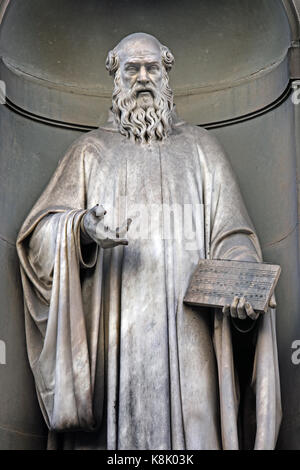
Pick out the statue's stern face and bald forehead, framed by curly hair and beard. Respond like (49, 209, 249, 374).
(119, 40, 163, 109)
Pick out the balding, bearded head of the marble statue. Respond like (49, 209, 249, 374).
(106, 33, 174, 143)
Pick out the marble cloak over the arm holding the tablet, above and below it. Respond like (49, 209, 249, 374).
(198, 133, 282, 449)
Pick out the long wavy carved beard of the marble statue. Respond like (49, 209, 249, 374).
(112, 70, 173, 143)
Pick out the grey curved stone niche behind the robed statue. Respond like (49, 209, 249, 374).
(0, 0, 300, 449)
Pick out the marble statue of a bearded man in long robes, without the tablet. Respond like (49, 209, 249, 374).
(17, 33, 281, 450)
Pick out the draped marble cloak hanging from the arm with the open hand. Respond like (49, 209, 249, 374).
(17, 135, 101, 431)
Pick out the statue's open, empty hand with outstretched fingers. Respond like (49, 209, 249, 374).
(83, 204, 131, 248)
